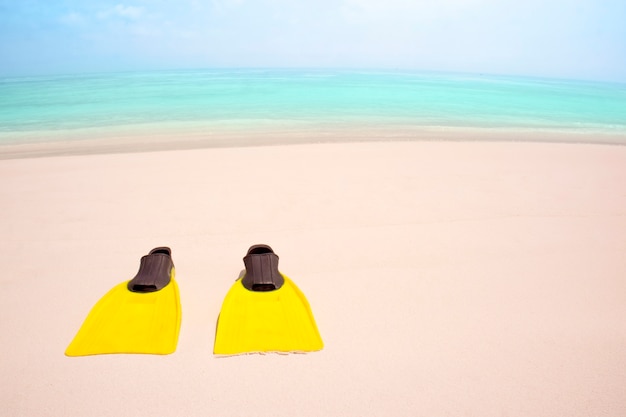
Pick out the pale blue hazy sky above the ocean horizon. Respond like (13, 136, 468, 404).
(0, 0, 626, 82)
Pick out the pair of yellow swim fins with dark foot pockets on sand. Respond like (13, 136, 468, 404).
(65, 245, 324, 356)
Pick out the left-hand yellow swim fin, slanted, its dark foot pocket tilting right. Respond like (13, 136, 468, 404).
(65, 247, 181, 356)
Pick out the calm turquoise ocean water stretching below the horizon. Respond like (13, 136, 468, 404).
(0, 69, 626, 144)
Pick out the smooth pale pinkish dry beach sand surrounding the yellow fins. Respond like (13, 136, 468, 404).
(0, 142, 626, 417)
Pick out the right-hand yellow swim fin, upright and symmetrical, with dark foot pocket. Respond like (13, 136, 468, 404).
(213, 245, 324, 355)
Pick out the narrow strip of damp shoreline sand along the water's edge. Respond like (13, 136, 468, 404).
(0, 126, 626, 160)
